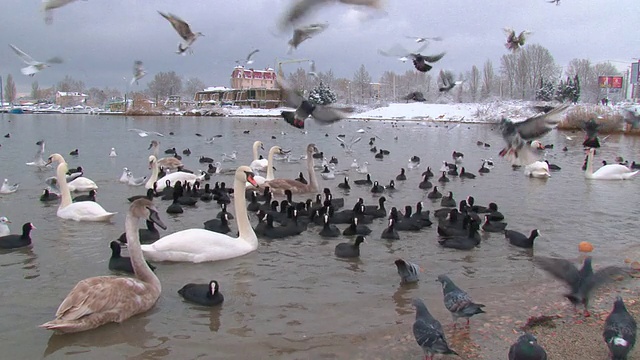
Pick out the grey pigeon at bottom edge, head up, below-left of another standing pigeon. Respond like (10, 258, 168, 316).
(413, 299, 458, 360)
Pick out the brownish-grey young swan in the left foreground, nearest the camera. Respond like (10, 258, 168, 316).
(40, 198, 167, 333)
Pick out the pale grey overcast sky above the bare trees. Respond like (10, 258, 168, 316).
(0, 0, 640, 93)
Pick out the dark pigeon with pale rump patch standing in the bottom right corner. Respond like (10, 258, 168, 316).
(602, 296, 637, 360)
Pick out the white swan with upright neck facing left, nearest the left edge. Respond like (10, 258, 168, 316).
(49, 154, 117, 221)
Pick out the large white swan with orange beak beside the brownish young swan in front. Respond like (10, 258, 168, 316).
(142, 166, 258, 263)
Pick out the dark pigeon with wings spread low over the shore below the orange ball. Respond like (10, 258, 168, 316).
(534, 256, 624, 316)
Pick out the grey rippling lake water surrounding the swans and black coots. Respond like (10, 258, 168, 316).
(0, 114, 640, 359)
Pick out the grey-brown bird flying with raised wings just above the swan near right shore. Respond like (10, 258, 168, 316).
(500, 104, 569, 165)
